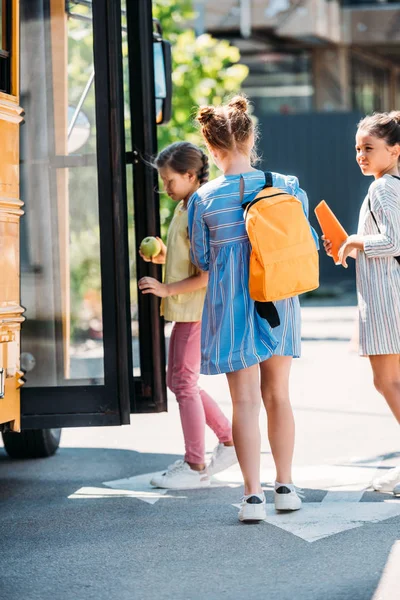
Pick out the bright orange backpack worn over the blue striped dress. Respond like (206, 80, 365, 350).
(240, 172, 319, 322)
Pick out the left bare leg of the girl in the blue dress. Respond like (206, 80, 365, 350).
(226, 365, 262, 495)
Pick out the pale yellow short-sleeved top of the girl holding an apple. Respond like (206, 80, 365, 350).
(160, 200, 207, 323)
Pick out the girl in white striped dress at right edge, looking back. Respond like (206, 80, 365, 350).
(324, 111, 400, 493)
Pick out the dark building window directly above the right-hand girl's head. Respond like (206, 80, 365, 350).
(351, 57, 390, 113)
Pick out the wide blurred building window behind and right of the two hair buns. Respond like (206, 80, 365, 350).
(242, 52, 314, 115)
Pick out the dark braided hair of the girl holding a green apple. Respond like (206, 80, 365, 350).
(154, 142, 209, 185)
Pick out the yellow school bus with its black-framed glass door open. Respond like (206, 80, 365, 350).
(0, 0, 171, 457)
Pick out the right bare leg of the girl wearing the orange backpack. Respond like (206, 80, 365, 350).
(260, 356, 295, 483)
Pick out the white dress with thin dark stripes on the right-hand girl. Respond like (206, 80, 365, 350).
(356, 175, 400, 356)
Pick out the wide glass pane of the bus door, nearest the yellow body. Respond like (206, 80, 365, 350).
(21, 0, 104, 387)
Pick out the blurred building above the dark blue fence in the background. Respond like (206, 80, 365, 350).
(195, 0, 400, 114)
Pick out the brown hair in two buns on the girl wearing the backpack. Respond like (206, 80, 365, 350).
(197, 95, 257, 161)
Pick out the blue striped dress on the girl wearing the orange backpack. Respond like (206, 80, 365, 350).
(188, 170, 318, 375)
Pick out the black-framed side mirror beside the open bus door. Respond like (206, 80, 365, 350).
(153, 38, 172, 125)
